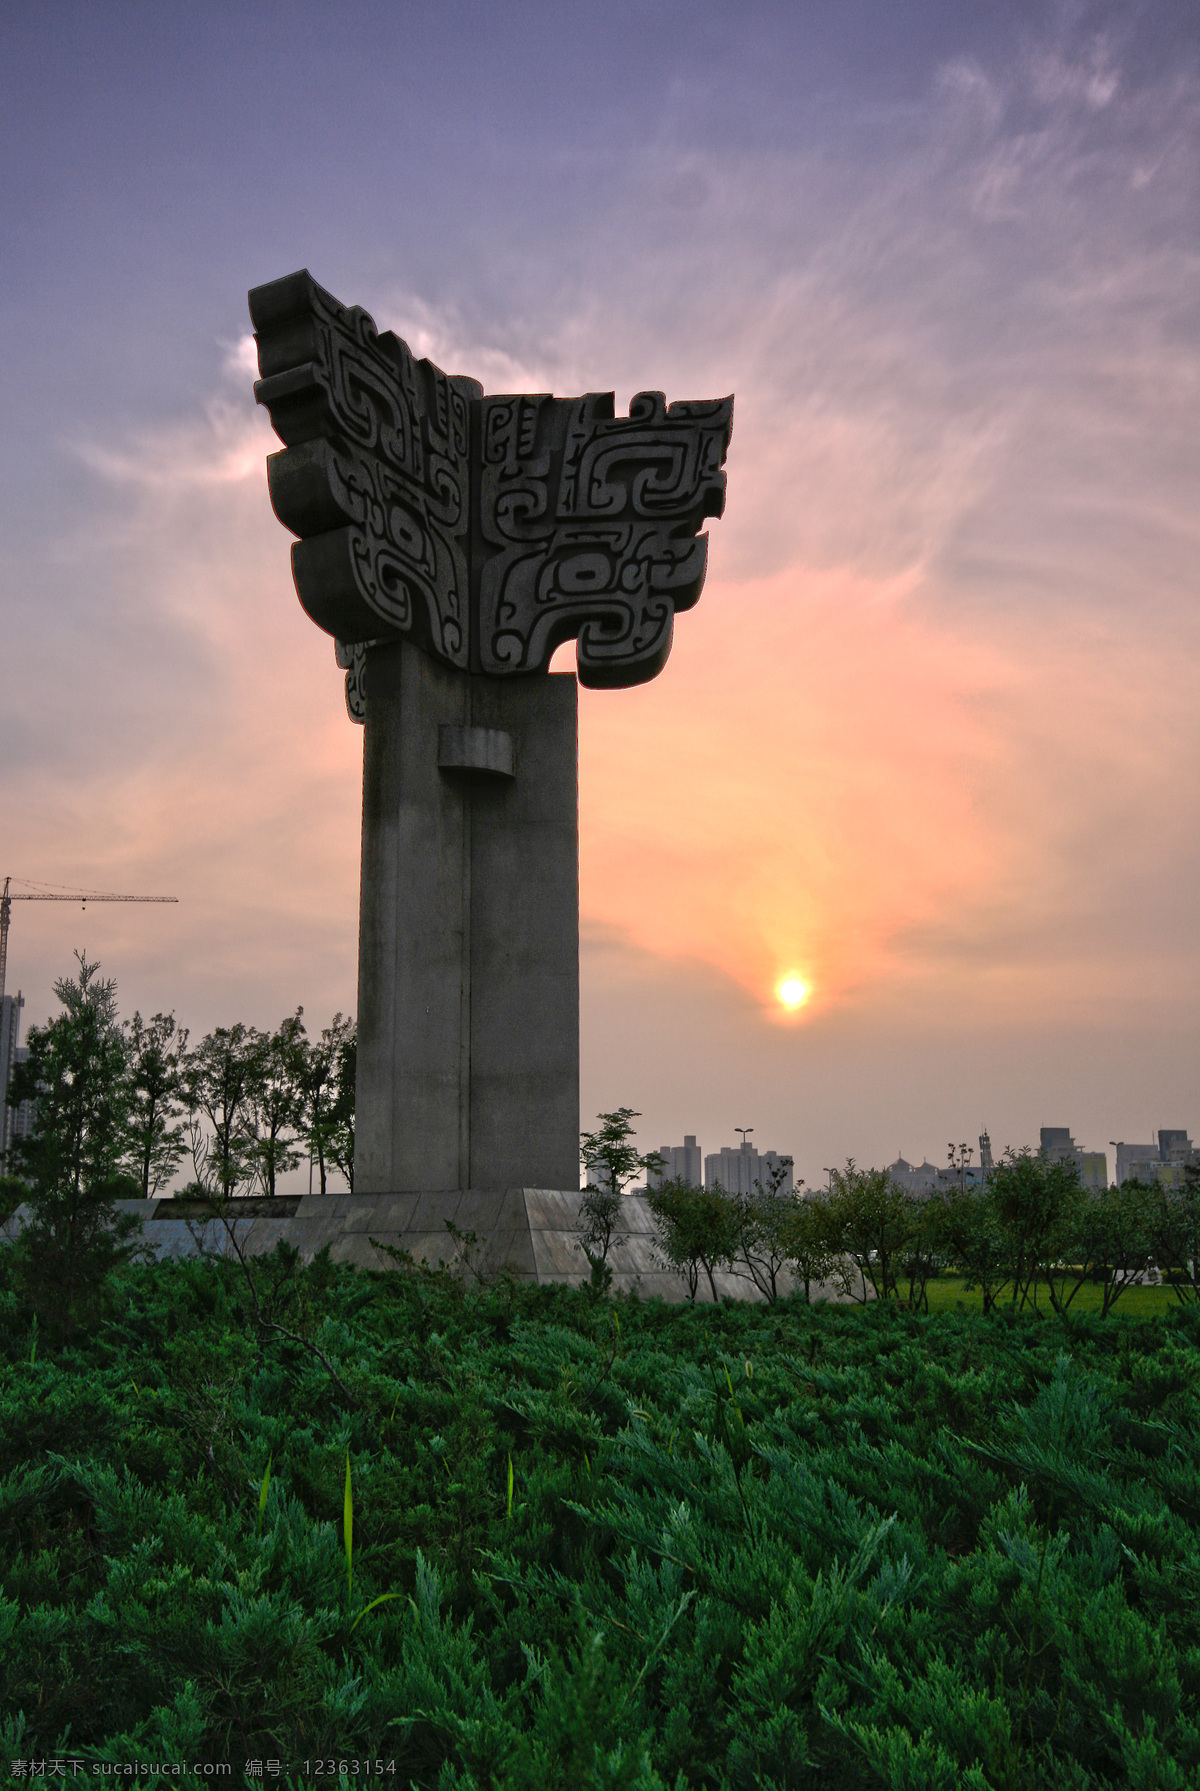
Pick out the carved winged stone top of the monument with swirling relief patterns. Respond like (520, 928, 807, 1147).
(251, 272, 733, 691)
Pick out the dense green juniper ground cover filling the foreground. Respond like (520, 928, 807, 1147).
(0, 1252, 1200, 1791)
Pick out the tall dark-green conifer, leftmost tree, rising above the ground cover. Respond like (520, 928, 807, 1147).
(9, 953, 140, 1343)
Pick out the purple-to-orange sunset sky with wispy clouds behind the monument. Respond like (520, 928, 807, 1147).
(0, 0, 1200, 1186)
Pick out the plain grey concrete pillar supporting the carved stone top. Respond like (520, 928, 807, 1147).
(355, 641, 579, 1193)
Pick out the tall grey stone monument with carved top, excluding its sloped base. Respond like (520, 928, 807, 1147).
(249, 272, 733, 1268)
